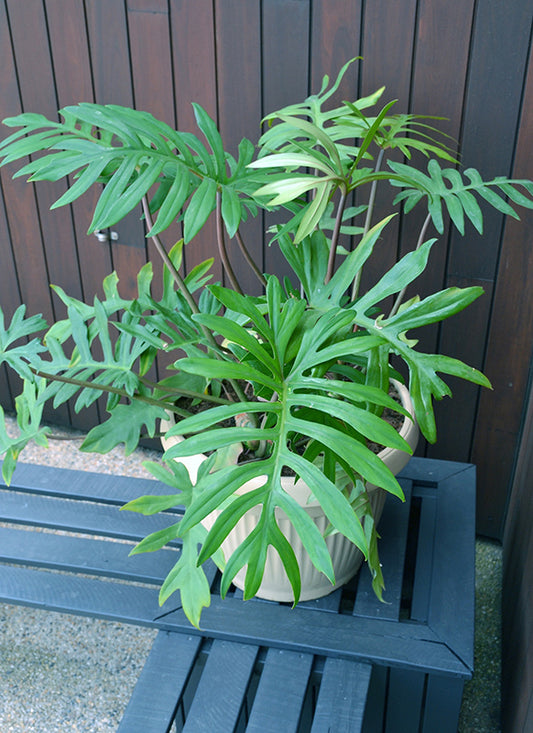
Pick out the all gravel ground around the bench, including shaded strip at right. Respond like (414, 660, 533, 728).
(0, 414, 501, 733)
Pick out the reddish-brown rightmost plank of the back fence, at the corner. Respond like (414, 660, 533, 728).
(472, 35, 533, 537)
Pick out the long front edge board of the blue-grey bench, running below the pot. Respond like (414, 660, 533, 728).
(0, 567, 470, 677)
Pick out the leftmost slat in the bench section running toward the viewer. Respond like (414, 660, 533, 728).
(118, 631, 201, 733)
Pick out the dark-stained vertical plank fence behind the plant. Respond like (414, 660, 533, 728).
(0, 0, 533, 537)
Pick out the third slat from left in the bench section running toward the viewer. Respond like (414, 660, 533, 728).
(246, 649, 313, 733)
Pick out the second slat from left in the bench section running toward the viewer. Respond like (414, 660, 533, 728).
(183, 641, 259, 733)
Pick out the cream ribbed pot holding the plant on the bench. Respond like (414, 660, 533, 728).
(162, 380, 419, 602)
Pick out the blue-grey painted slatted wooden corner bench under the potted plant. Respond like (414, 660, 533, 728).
(0, 458, 475, 733)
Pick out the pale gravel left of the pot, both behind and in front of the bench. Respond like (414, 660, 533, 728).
(0, 419, 159, 733)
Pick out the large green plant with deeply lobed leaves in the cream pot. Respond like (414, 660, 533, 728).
(0, 64, 533, 624)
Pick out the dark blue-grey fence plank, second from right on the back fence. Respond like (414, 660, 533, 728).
(427, 0, 533, 468)
